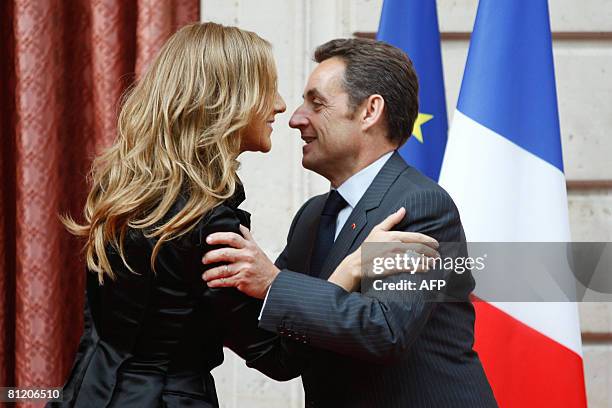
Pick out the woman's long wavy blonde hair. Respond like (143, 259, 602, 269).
(62, 23, 276, 283)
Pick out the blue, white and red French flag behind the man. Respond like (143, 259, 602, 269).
(440, 0, 586, 407)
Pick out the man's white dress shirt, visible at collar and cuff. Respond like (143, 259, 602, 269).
(259, 151, 393, 320)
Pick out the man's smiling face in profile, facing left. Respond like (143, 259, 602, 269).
(289, 57, 361, 181)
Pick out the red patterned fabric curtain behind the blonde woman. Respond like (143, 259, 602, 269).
(0, 0, 199, 396)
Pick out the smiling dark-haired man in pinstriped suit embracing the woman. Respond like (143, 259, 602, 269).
(205, 39, 496, 407)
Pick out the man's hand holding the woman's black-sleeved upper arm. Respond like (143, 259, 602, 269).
(202, 225, 280, 299)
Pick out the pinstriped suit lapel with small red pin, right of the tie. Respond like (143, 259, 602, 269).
(318, 151, 408, 279)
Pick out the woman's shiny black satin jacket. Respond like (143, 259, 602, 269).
(50, 186, 298, 408)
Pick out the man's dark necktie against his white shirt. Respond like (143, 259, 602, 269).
(310, 190, 348, 276)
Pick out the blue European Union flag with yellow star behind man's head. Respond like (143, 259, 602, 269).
(377, 0, 448, 180)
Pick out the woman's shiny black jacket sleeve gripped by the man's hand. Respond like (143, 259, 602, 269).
(198, 207, 300, 381)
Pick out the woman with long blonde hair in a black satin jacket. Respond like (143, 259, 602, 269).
(51, 23, 436, 408)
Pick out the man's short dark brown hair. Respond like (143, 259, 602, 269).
(314, 38, 419, 146)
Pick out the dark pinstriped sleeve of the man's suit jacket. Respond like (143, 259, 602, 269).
(260, 191, 471, 363)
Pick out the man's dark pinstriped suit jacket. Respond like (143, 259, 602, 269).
(260, 152, 496, 407)
